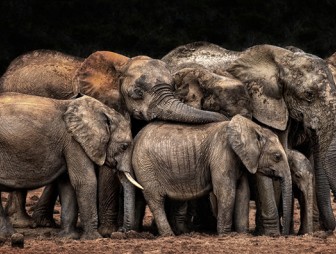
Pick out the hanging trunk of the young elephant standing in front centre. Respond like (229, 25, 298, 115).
(280, 174, 293, 235)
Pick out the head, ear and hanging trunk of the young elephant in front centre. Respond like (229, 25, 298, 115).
(228, 115, 292, 235)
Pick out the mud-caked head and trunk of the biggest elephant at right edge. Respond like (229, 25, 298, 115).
(226, 45, 336, 230)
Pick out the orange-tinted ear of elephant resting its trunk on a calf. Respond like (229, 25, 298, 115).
(73, 51, 129, 112)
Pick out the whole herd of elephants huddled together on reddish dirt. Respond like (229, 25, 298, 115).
(0, 42, 336, 239)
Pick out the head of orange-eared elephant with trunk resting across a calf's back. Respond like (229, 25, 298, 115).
(74, 51, 226, 123)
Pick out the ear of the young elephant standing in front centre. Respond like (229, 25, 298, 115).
(228, 115, 267, 174)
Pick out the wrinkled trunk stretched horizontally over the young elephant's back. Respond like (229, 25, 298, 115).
(148, 84, 229, 123)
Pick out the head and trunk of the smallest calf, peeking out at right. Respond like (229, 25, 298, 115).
(287, 150, 314, 234)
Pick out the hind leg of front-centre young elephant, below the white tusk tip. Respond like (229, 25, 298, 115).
(144, 191, 174, 236)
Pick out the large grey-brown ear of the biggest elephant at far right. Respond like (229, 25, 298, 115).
(227, 45, 290, 130)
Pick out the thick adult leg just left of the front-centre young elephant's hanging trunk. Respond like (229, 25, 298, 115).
(251, 173, 280, 236)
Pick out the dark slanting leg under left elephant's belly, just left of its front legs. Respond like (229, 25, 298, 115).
(32, 183, 58, 227)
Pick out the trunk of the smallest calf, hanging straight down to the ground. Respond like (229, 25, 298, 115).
(299, 183, 314, 235)
